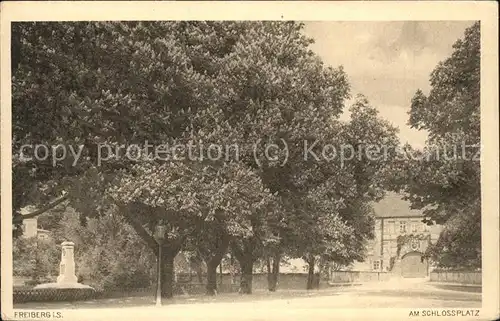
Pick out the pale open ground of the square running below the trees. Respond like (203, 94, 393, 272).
(14, 282, 481, 309)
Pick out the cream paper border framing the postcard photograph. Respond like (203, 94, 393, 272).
(0, 1, 500, 320)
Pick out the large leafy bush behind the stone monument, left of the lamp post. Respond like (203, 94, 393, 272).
(58, 211, 156, 291)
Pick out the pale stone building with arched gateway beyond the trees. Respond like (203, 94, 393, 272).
(352, 193, 442, 277)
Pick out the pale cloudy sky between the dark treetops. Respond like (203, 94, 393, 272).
(305, 21, 473, 148)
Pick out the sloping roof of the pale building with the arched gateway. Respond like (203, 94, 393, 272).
(373, 192, 423, 218)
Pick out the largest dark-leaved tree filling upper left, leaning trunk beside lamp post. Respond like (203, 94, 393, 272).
(13, 22, 270, 296)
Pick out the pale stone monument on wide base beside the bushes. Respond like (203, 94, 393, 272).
(35, 242, 92, 289)
